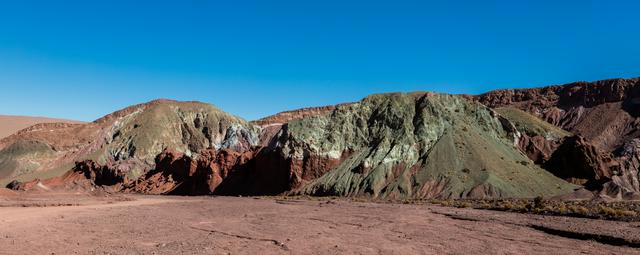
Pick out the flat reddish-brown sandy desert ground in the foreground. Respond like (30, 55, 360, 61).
(0, 194, 640, 254)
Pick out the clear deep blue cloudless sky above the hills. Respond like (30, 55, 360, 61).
(0, 0, 640, 120)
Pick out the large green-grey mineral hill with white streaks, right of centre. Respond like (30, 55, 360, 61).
(276, 93, 571, 198)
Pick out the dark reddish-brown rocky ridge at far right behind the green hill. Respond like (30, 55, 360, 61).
(476, 78, 640, 198)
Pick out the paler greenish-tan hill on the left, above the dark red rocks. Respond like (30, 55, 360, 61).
(0, 100, 258, 183)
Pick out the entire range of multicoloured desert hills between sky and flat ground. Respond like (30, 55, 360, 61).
(11, 79, 640, 199)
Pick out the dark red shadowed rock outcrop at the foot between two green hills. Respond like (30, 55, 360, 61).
(122, 147, 292, 195)
